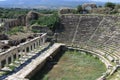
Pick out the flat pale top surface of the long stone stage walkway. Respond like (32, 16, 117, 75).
(6, 43, 62, 80)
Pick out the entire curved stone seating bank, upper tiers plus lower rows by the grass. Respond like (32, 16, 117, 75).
(56, 14, 120, 80)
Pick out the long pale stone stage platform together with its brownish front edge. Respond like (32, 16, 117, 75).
(7, 43, 63, 80)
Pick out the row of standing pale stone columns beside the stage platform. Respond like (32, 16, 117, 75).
(0, 37, 45, 69)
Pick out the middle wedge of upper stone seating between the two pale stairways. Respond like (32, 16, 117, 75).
(74, 16, 102, 42)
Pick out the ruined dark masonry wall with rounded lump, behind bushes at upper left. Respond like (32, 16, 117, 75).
(0, 11, 40, 30)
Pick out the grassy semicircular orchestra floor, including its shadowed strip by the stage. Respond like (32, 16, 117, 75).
(31, 51, 106, 80)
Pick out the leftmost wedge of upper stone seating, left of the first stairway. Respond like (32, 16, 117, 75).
(58, 16, 79, 43)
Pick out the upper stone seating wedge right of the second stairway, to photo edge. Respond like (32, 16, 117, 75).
(89, 16, 120, 49)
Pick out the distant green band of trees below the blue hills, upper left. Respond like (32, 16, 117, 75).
(0, 8, 57, 18)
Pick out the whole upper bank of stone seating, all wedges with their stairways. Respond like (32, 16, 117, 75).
(58, 14, 120, 51)
